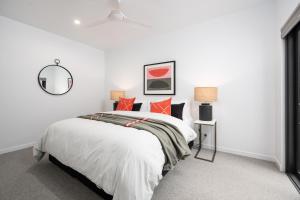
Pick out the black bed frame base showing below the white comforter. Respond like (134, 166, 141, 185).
(49, 141, 194, 200)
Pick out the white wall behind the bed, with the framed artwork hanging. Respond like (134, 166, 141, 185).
(106, 1, 279, 160)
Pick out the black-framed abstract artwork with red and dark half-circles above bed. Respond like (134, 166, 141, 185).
(144, 61, 176, 95)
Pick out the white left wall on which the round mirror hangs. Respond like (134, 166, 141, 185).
(0, 17, 105, 153)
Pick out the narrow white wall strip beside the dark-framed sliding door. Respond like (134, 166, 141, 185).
(275, 0, 299, 171)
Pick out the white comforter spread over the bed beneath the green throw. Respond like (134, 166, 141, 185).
(34, 111, 196, 200)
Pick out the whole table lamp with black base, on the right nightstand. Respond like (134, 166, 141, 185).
(194, 87, 218, 121)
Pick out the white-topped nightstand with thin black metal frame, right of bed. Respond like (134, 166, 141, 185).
(194, 120, 217, 162)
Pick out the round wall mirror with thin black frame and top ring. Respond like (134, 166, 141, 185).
(38, 59, 73, 95)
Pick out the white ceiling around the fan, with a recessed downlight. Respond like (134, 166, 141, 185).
(0, 0, 269, 49)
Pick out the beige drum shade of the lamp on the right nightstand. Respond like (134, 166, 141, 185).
(194, 87, 218, 103)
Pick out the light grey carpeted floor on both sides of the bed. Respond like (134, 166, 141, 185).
(0, 149, 300, 200)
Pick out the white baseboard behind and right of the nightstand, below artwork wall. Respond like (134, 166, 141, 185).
(202, 144, 276, 163)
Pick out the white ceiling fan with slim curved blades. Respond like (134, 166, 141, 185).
(87, 0, 151, 28)
